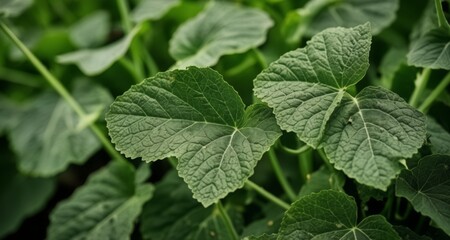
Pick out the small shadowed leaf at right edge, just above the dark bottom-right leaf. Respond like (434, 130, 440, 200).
(427, 116, 450, 155)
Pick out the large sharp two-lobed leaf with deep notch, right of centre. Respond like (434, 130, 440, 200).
(254, 24, 426, 190)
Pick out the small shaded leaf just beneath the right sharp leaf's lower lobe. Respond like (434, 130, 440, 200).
(299, 166, 345, 197)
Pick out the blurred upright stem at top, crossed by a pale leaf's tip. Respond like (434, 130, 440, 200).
(117, 0, 144, 83)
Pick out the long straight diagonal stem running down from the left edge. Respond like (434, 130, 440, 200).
(0, 19, 125, 161)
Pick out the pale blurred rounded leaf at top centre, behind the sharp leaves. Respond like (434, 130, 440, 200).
(169, 1, 273, 68)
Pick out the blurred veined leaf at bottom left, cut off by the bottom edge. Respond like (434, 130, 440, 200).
(47, 161, 153, 240)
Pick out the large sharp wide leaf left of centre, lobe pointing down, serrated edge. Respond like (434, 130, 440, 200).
(106, 67, 280, 207)
